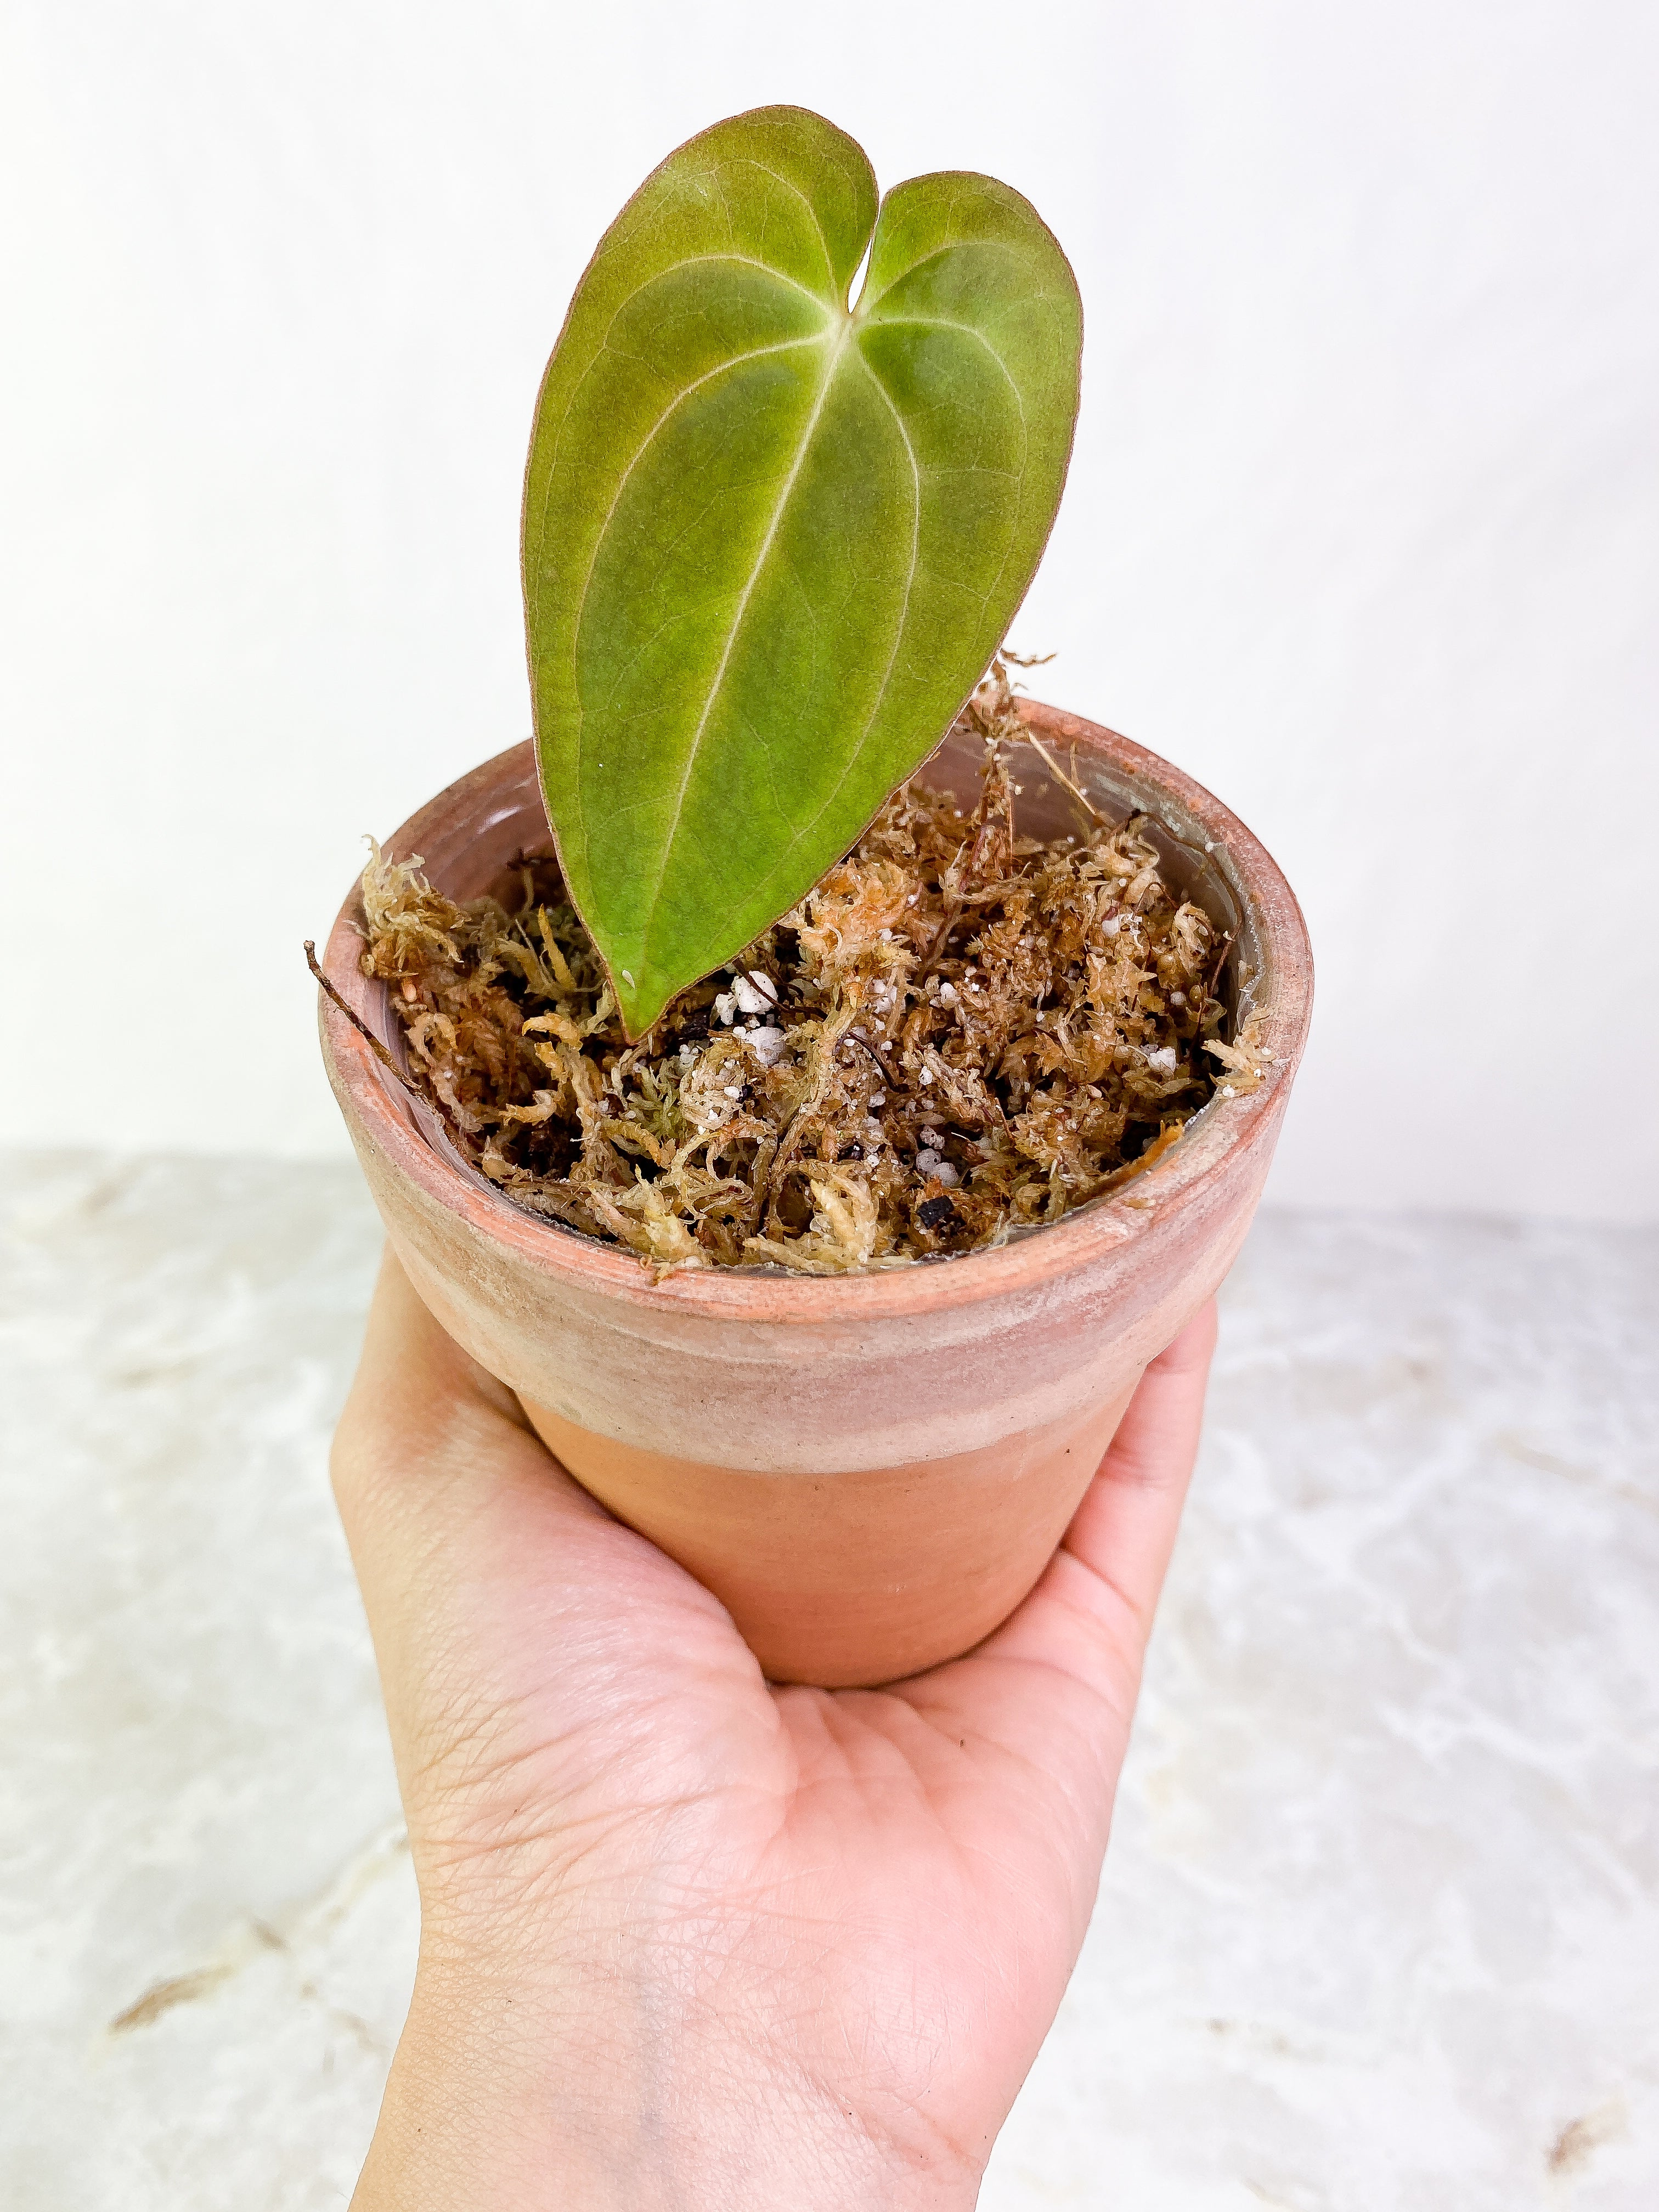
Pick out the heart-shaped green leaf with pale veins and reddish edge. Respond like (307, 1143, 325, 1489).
(524, 109, 1082, 1035)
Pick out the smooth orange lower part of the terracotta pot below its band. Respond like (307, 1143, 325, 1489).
(520, 1376, 1139, 1690)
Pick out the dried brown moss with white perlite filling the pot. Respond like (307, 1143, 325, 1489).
(363, 668, 1259, 1274)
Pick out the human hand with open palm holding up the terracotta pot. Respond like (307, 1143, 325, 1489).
(334, 1256, 1215, 2212)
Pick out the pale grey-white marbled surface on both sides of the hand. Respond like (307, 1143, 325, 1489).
(0, 1157, 1659, 2212)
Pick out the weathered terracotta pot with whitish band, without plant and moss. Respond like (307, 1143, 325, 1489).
(321, 703, 1312, 1685)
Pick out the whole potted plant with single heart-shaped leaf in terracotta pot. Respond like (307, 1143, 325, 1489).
(319, 109, 1312, 1685)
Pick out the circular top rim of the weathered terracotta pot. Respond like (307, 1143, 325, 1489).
(319, 699, 1314, 1327)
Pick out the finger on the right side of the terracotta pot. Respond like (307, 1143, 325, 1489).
(984, 1301, 1217, 1725)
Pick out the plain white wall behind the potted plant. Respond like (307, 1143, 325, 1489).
(0, 0, 1659, 1219)
